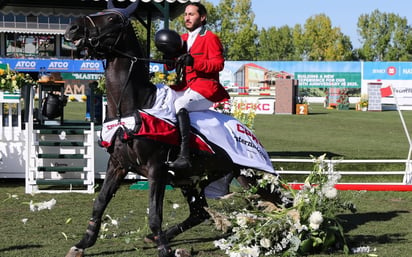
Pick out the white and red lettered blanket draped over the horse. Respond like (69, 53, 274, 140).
(102, 85, 276, 173)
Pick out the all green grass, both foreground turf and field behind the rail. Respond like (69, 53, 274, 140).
(0, 103, 412, 254)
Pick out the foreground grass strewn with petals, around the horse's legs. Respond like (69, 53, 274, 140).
(0, 180, 412, 257)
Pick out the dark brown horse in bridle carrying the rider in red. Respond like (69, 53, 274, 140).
(64, 0, 279, 257)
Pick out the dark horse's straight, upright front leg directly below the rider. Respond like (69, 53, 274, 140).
(148, 165, 174, 257)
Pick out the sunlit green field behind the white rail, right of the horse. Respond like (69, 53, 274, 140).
(255, 104, 412, 159)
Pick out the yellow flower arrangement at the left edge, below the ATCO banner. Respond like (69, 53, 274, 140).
(0, 64, 36, 93)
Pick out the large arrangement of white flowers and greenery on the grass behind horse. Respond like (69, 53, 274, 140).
(208, 155, 356, 257)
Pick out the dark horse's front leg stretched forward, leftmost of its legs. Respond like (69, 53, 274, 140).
(66, 158, 126, 257)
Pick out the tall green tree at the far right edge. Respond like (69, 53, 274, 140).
(358, 10, 412, 61)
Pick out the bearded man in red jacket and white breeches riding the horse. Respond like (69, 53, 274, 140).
(168, 2, 230, 169)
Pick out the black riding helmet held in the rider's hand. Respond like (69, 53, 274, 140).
(155, 29, 185, 57)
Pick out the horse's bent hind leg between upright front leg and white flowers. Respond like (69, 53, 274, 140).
(145, 184, 210, 242)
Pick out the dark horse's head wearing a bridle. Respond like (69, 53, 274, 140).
(64, 0, 139, 57)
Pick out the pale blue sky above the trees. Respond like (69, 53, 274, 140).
(208, 0, 412, 48)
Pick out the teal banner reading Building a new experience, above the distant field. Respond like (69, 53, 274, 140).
(295, 72, 361, 88)
